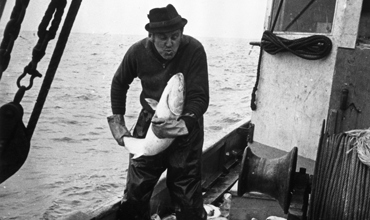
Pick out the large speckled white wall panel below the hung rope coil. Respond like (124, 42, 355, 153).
(251, 46, 336, 159)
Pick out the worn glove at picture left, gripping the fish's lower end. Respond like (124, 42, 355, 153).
(107, 114, 131, 146)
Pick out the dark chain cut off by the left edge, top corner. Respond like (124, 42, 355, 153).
(0, 0, 29, 79)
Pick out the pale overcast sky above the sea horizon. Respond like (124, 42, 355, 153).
(0, 0, 266, 39)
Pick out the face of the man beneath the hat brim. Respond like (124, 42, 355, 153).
(152, 30, 182, 60)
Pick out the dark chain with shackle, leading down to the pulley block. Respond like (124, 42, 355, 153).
(17, 0, 67, 90)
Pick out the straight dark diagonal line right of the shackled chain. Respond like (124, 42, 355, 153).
(27, 0, 82, 140)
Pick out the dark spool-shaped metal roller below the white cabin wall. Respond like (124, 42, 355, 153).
(238, 147, 298, 213)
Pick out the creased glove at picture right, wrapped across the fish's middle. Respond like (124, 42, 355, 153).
(152, 115, 189, 138)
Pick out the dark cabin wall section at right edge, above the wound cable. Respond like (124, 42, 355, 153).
(327, 44, 370, 134)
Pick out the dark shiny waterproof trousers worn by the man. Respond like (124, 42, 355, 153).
(120, 110, 207, 220)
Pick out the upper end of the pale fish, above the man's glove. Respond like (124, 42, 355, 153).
(167, 73, 185, 116)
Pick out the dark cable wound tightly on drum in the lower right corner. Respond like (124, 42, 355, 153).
(309, 132, 370, 220)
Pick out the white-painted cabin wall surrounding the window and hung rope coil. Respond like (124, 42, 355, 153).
(251, 0, 369, 159)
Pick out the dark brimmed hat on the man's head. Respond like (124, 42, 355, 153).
(145, 4, 188, 33)
